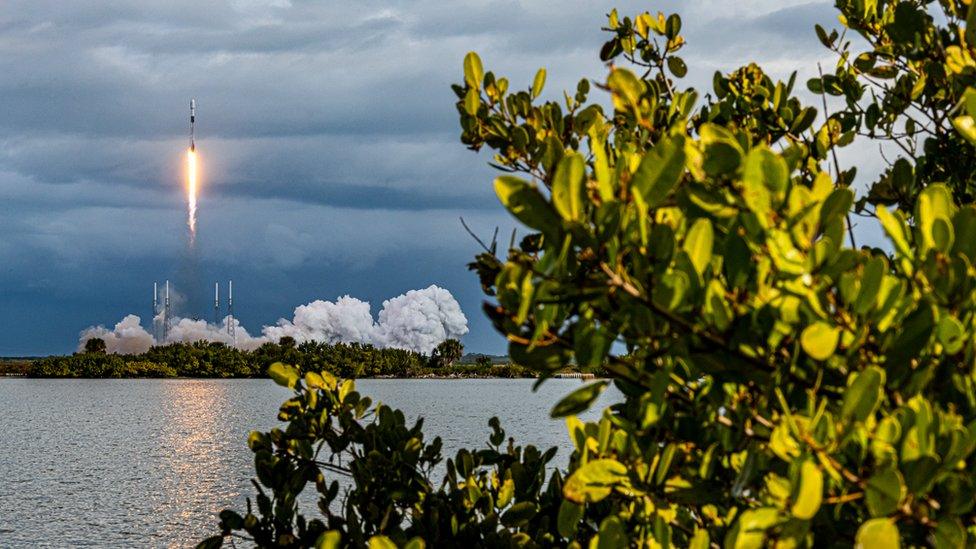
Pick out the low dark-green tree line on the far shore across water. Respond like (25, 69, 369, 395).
(19, 337, 534, 378)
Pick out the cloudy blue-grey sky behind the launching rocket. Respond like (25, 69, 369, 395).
(0, 0, 875, 356)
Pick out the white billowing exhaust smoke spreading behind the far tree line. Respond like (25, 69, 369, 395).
(78, 285, 468, 354)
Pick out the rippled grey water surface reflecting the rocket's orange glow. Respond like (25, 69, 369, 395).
(0, 378, 620, 548)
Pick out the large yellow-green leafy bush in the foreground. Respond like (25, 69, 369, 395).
(202, 0, 976, 548)
